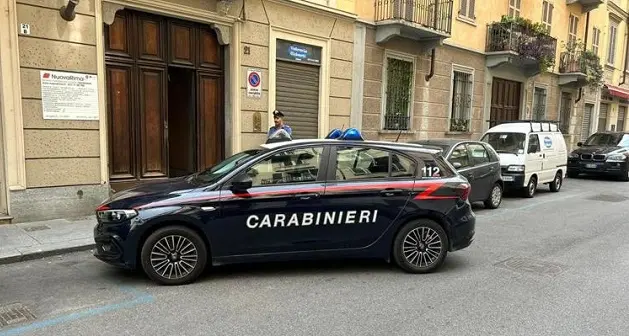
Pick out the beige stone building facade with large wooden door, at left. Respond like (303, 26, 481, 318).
(0, 0, 356, 222)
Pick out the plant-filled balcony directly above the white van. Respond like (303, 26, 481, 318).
(485, 17, 557, 77)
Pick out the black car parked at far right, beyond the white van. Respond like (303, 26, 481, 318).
(568, 132, 629, 182)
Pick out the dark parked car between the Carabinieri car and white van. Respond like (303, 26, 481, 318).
(411, 139, 504, 209)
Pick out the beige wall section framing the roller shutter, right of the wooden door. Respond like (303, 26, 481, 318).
(239, 0, 354, 149)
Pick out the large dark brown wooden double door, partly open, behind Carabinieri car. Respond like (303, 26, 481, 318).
(105, 10, 225, 190)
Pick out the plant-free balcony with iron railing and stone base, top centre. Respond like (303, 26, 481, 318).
(375, 0, 454, 49)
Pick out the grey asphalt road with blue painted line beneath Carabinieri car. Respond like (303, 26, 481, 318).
(0, 179, 629, 336)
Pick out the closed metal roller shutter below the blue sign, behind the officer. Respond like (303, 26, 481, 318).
(275, 60, 320, 139)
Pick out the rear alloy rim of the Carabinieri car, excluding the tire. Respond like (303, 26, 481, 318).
(402, 227, 443, 267)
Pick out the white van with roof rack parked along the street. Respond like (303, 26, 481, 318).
(481, 120, 568, 197)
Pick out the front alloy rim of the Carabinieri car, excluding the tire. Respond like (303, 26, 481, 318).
(150, 235, 199, 280)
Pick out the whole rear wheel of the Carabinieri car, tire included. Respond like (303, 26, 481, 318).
(392, 219, 449, 274)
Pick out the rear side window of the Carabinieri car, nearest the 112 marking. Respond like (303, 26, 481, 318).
(336, 147, 417, 181)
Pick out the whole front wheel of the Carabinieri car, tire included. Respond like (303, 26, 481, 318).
(141, 226, 208, 286)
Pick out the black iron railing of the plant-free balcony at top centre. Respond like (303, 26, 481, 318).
(375, 0, 454, 34)
